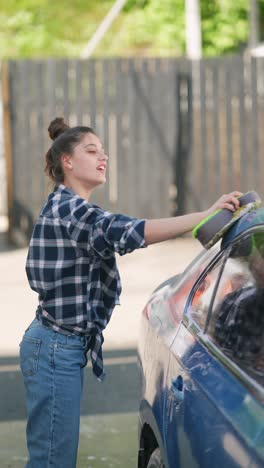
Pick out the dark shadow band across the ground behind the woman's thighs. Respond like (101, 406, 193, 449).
(0, 349, 140, 422)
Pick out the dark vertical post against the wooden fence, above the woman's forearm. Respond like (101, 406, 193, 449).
(174, 73, 192, 215)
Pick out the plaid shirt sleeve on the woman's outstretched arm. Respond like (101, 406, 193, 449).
(66, 197, 146, 258)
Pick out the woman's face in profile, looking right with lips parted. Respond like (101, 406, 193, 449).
(64, 133, 108, 190)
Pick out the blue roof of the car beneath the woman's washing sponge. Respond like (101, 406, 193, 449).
(221, 208, 264, 248)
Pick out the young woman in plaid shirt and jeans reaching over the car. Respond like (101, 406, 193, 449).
(20, 118, 240, 468)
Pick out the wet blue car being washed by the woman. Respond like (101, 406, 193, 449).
(138, 208, 264, 468)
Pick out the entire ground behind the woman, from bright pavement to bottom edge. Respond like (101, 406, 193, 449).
(0, 232, 201, 468)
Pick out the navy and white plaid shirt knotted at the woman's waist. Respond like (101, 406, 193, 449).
(26, 184, 145, 380)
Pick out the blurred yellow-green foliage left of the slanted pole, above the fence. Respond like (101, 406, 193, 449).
(0, 0, 113, 57)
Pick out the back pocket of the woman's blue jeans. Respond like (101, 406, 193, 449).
(19, 336, 41, 377)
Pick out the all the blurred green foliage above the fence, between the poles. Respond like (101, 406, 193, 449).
(0, 0, 264, 57)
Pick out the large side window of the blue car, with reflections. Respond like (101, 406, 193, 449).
(207, 231, 264, 385)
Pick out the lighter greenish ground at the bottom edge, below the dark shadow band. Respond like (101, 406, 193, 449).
(0, 413, 137, 468)
